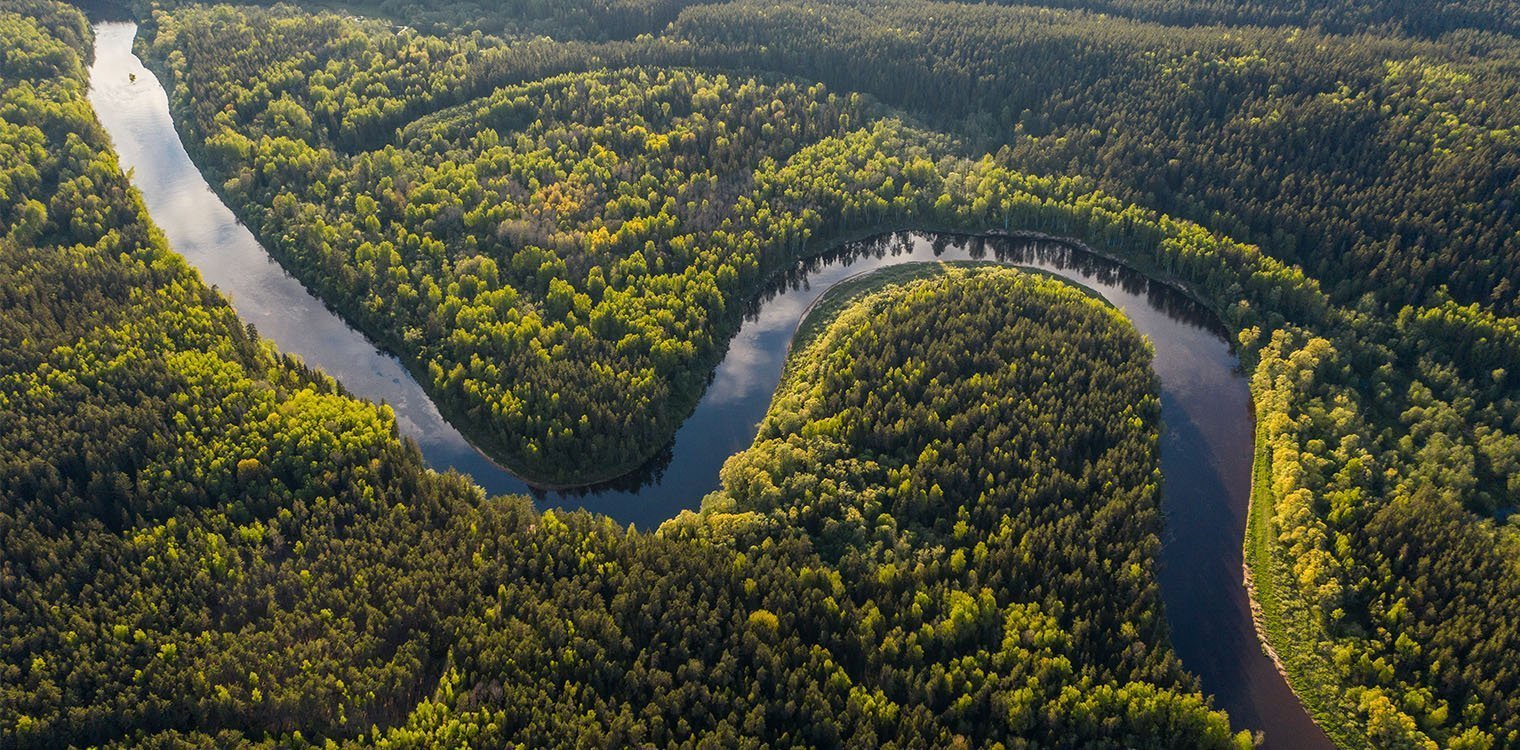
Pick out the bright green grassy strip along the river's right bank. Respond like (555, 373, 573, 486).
(1245, 410, 1371, 748)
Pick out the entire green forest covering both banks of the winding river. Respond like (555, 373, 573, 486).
(0, 0, 1520, 748)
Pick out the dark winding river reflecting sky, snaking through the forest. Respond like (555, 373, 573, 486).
(90, 23, 1332, 748)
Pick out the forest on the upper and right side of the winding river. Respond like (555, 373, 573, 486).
(136, 3, 1520, 747)
